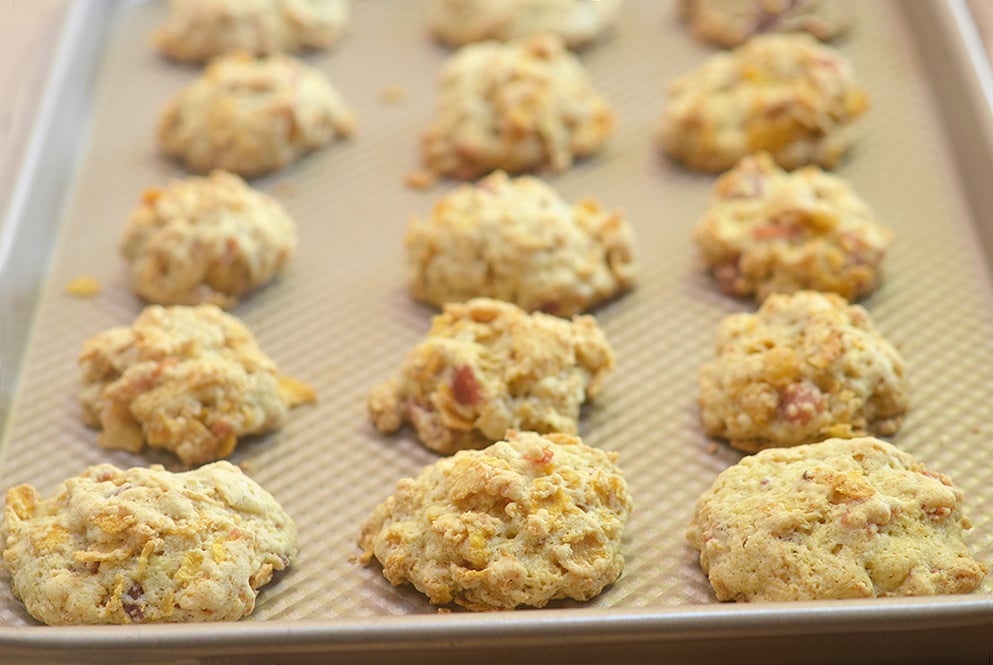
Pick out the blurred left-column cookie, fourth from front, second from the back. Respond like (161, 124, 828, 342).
(158, 53, 356, 177)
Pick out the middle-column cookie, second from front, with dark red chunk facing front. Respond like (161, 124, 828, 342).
(368, 298, 614, 454)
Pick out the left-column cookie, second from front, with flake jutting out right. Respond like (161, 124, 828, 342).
(79, 305, 315, 465)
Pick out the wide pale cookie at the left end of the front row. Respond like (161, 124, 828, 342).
(0, 462, 296, 625)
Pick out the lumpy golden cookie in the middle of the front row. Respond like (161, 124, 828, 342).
(359, 431, 631, 611)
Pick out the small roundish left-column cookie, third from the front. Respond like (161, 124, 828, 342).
(120, 171, 296, 308)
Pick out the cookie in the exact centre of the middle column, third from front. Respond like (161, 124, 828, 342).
(406, 171, 637, 316)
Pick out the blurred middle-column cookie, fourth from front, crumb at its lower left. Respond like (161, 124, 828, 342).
(421, 35, 614, 180)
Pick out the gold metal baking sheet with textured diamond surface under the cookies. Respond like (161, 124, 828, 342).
(0, 0, 993, 652)
